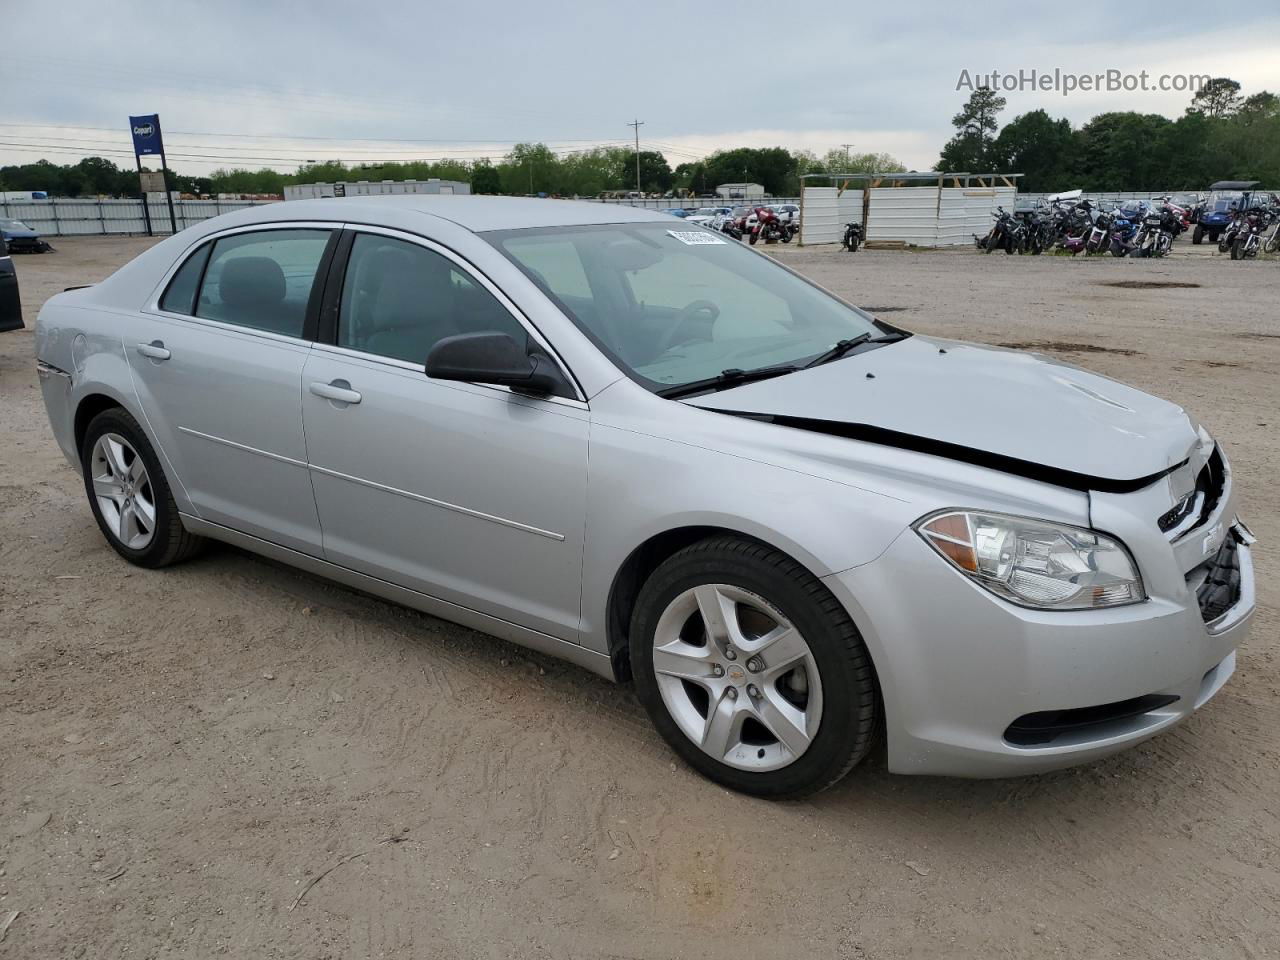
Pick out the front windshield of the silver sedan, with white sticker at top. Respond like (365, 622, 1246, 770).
(486, 223, 892, 390)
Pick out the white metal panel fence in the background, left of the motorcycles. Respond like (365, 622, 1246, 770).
(800, 186, 1015, 247)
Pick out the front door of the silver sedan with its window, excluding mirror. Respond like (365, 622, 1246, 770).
(302, 233, 588, 643)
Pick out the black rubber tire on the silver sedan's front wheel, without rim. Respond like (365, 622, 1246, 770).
(630, 535, 879, 800)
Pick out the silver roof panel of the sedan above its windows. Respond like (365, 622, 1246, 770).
(241, 193, 669, 233)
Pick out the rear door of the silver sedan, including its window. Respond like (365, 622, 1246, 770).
(124, 224, 337, 556)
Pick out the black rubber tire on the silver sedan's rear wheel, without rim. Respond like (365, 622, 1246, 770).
(81, 407, 205, 568)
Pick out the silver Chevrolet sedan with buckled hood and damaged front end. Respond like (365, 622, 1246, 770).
(36, 196, 1254, 797)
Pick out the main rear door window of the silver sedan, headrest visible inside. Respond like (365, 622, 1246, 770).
(194, 229, 330, 337)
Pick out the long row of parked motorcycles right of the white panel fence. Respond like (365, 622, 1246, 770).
(973, 193, 1280, 260)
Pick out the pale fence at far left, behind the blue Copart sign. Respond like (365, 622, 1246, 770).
(0, 196, 278, 237)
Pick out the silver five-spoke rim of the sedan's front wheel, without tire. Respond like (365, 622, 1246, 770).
(653, 584, 822, 772)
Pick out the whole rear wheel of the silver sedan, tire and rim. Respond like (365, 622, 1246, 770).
(81, 407, 204, 567)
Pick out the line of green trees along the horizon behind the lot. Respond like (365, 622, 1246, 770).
(0, 77, 1280, 197)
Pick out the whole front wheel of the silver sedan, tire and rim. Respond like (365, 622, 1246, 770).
(630, 536, 877, 799)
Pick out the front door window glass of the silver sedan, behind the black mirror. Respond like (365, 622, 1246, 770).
(338, 233, 529, 364)
